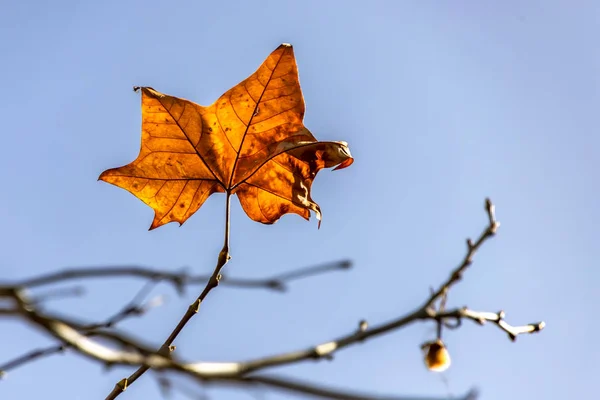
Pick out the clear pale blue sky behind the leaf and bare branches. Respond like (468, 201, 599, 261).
(0, 0, 600, 400)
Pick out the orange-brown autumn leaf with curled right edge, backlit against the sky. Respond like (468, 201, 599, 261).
(99, 44, 353, 229)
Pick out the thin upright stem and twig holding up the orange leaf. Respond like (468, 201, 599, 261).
(106, 190, 231, 400)
